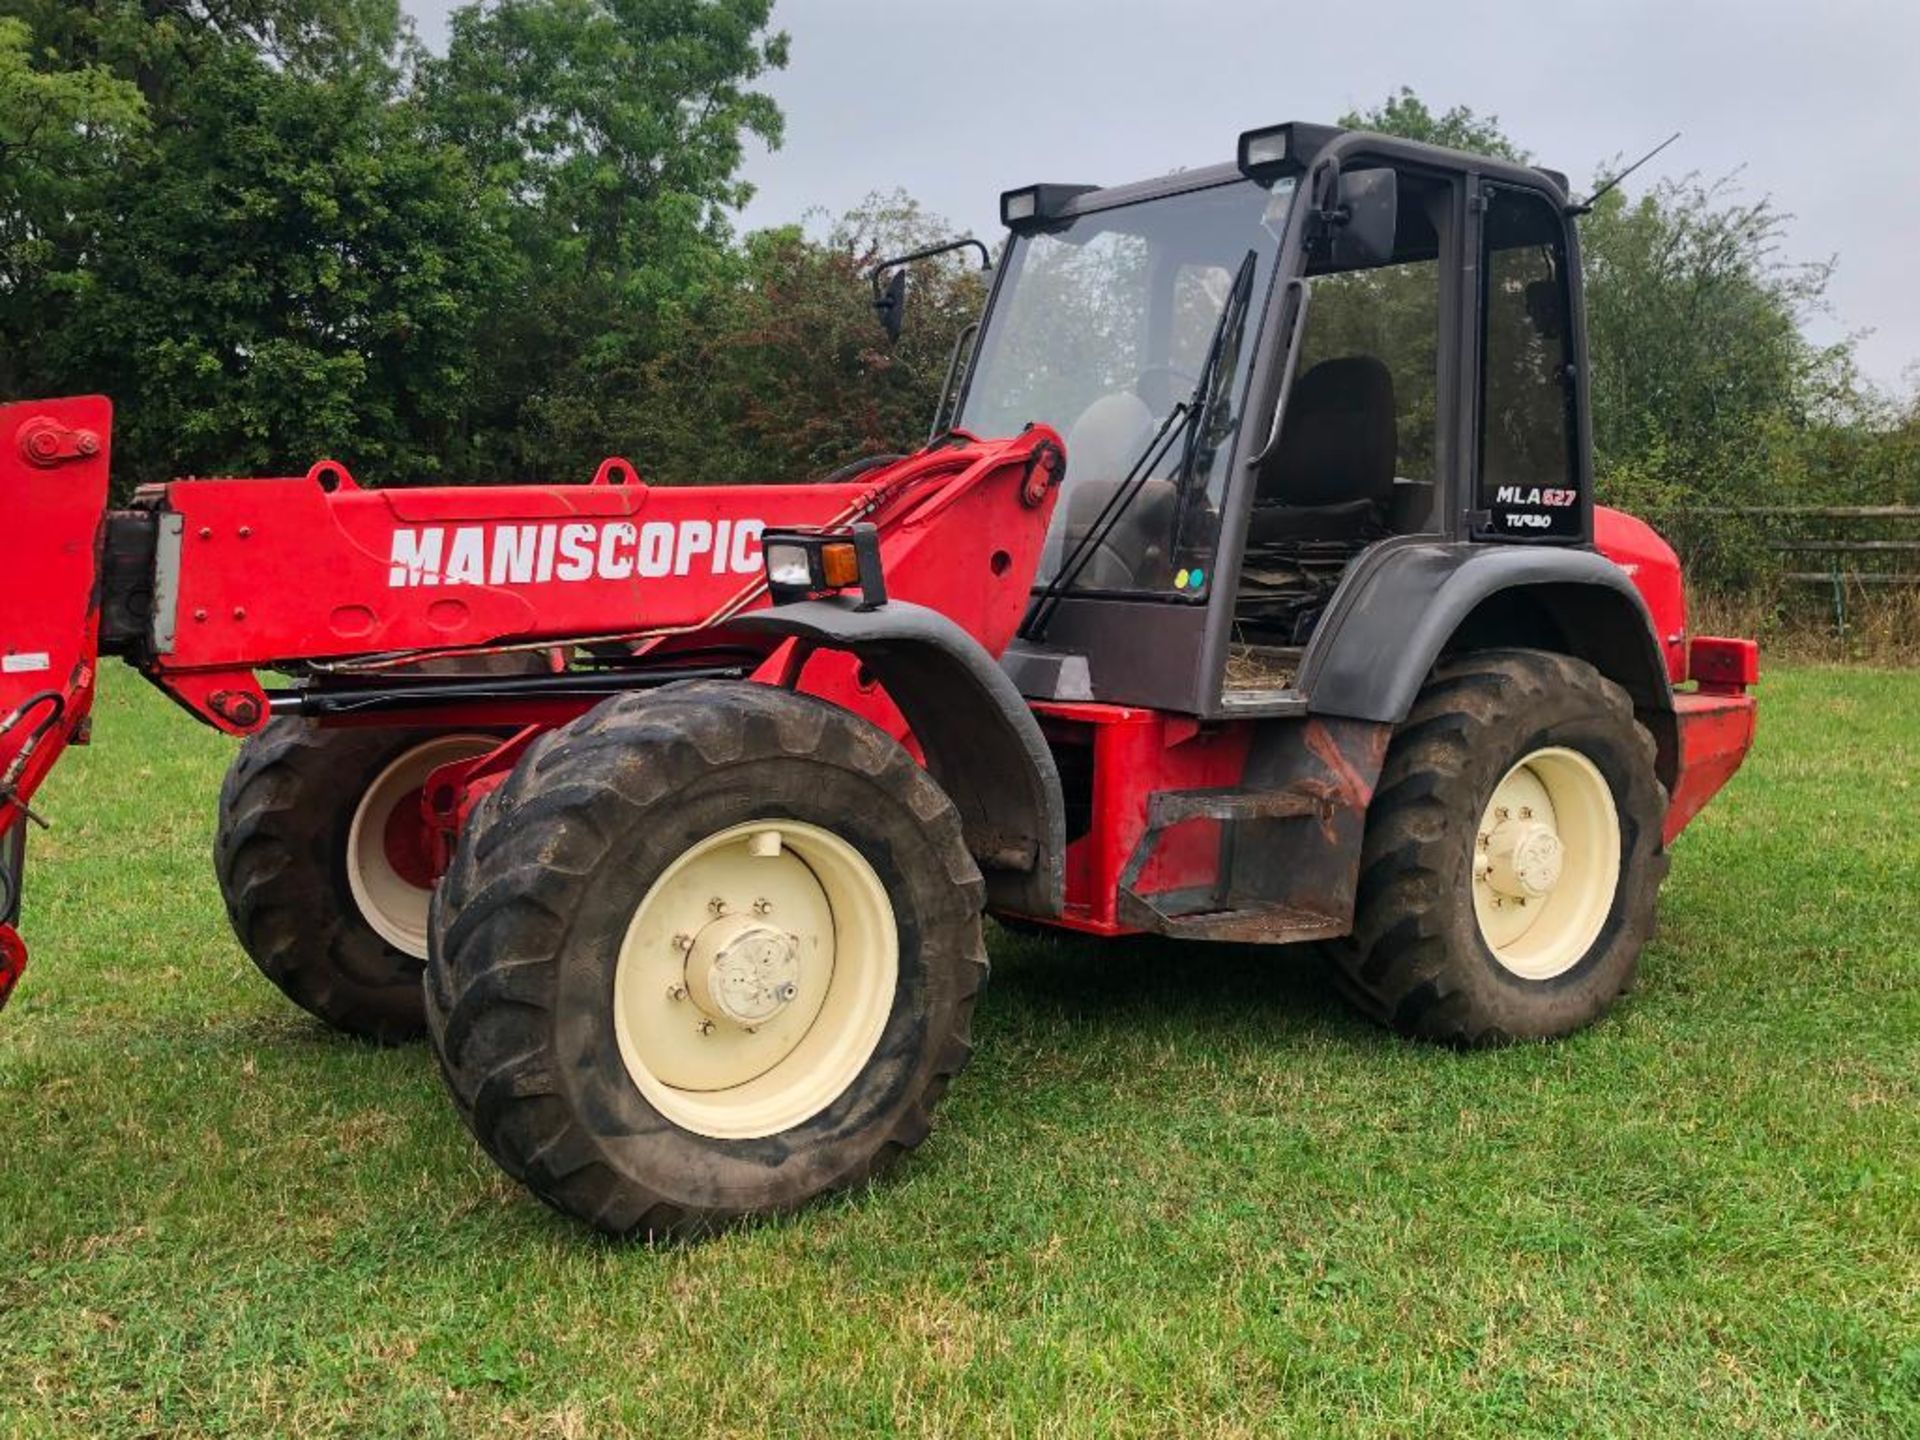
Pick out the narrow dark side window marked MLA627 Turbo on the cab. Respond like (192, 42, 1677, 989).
(1480, 186, 1582, 540)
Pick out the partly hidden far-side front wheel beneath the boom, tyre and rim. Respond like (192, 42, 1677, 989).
(213, 718, 499, 1044)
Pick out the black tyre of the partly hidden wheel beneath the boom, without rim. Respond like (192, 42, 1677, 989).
(213, 718, 437, 1044)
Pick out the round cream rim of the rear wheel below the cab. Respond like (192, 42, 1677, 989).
(1473, 747, 1620, 979)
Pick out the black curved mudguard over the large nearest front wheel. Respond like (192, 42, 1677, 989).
(732, 599, 1066, 916)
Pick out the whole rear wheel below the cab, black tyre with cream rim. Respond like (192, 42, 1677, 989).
(1329, 651, 1667, 1044)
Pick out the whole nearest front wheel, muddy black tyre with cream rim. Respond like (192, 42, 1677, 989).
(426, 684, 987, 1235)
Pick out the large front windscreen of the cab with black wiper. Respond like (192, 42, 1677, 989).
(958, 179, 1292, 599)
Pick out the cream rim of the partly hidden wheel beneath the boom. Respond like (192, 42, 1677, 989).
(346, 735, 499, 960)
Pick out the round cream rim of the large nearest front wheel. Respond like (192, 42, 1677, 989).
(614, 820, 900, 1140)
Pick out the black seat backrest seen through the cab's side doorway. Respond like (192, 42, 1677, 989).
(1246, 355, 1400, 545)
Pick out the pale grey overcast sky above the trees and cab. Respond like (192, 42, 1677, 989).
(403, 0, 1920, 390)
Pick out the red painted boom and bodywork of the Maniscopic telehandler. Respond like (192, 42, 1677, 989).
(0, 397, 1757, 1002)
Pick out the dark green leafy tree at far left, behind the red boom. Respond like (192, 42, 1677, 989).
(0, 0, 492, 486)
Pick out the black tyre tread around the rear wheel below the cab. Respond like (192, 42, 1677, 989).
(1327, 649, 1668, 1046)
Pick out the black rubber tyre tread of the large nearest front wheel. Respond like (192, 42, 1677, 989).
(424, 682, 987, 1236)
